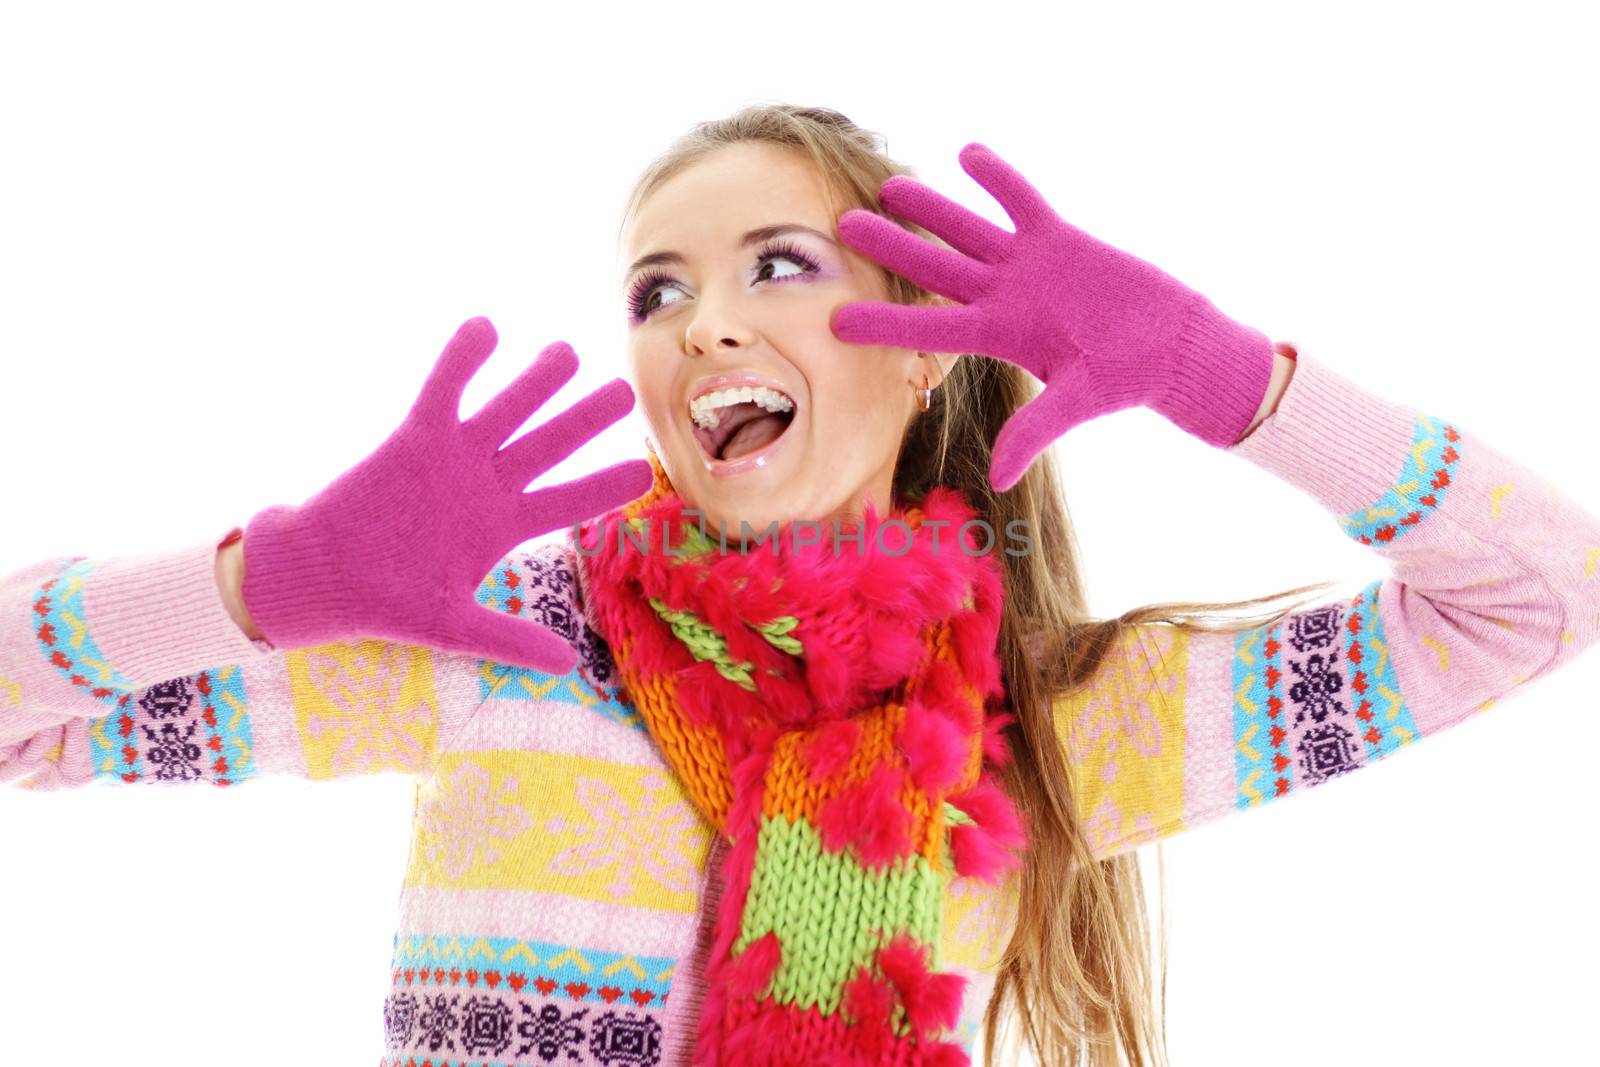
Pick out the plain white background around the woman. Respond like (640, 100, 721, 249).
(0, 2, 1600, 1067)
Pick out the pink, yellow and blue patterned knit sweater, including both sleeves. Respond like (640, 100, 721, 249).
(9, 354, 1600, 1067)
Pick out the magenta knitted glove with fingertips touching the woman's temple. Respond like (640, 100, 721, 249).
(832, 142, 1272, 491)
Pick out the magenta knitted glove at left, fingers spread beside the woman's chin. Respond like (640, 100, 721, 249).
(243, 317, 651, 673)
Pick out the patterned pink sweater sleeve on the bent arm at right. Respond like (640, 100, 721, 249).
(1053, 354, 1600, 857)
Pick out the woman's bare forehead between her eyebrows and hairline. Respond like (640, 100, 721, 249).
(622, 144, 835, 255)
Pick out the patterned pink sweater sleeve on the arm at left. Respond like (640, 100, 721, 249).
(0, 528, 576, 789)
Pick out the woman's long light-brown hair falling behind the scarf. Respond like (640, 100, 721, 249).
(619, 104, 1333, 1067)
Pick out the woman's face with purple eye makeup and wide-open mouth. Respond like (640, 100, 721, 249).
(619, 144, 957, 542)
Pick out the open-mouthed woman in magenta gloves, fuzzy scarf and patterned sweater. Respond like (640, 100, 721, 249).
(0, 106, 1600, 1064)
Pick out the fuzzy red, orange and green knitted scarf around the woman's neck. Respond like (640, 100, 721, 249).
(576, 453, 1026, 1067)
